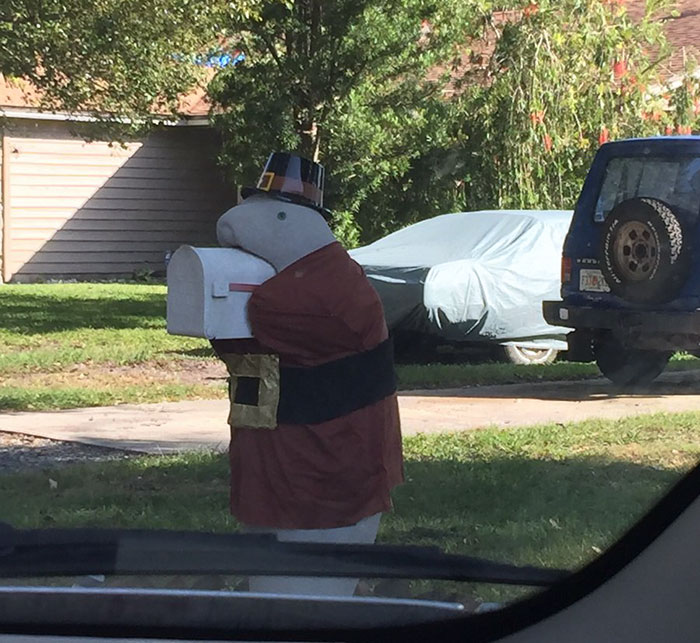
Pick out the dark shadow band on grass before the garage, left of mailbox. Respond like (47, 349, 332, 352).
(0, 293, 165, 334)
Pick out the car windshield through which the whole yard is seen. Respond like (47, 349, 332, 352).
(0, 0, 700, 627)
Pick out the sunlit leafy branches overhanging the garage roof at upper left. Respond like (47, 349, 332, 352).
(0, 0, 254, 124)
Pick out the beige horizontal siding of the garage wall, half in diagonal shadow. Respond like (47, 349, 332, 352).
(4, 122, 235, 281)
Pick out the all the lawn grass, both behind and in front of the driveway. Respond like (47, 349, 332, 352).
(0, 284, 700, 600)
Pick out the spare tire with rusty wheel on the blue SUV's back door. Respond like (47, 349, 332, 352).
(600, 198, 691, 304)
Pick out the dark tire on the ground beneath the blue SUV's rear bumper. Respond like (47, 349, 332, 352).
(593, 334, 673, 387)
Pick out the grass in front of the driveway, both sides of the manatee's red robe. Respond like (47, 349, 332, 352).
(0, 413, 700, 600)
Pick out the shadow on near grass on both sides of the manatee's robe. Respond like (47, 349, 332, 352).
(0, 451, 680, 567)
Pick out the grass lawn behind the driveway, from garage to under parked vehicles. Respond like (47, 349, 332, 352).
(0, 284, 700, 410)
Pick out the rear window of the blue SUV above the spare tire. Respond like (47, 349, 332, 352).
(594, 156, 700, 223)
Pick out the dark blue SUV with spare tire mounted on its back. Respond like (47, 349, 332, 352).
(543, 136, 700, 386)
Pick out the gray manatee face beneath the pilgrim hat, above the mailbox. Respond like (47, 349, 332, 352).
(216, 194, 336, 272)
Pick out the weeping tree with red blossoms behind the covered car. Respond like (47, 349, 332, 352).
(454, 0, 700, 209)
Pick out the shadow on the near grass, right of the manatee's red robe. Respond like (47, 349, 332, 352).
(387, 457, 680, 557)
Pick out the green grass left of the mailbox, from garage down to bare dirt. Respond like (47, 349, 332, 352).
(0, 284, 208, 375)
